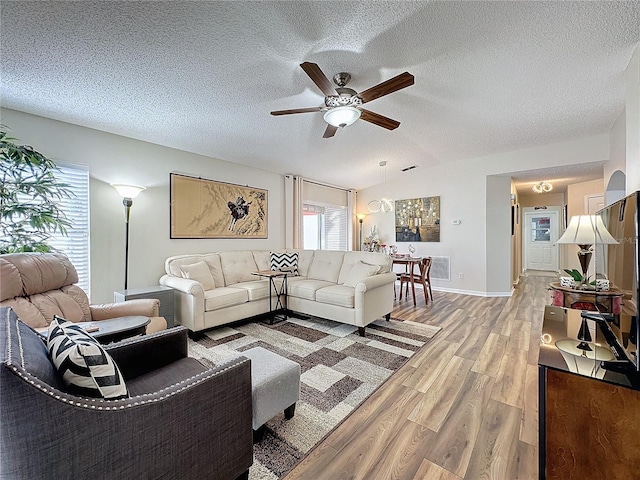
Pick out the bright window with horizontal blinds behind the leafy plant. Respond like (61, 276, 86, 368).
(47, 165, 91, 295)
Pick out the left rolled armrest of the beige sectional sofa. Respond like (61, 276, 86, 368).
(160, 275, 204, 332)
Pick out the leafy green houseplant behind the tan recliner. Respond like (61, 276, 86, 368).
(0, 126, 73, 253)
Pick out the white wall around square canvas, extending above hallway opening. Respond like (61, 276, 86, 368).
(357, 135, 609, 295)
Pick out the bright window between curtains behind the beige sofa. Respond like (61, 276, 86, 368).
(302, 202, 348, 251)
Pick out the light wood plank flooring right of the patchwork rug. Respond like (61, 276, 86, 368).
(285, 273, 550, 480)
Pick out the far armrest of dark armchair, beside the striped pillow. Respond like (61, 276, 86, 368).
(105, 327, 188, 380)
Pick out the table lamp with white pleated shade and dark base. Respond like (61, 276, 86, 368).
(556, 215, 618, 289)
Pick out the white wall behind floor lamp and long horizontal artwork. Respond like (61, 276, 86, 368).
(0, 109, 285, 303)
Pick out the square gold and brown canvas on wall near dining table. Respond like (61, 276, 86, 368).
(395, 196, 440, 242)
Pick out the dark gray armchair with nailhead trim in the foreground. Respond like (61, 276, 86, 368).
(0, 308, 253, 480)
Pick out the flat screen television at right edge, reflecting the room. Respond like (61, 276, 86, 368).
(594, 191, 640, 372)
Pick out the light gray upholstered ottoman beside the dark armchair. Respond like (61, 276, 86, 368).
(242, 347, 300, 442)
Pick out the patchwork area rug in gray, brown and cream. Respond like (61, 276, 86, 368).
(189, 318, 440, 480)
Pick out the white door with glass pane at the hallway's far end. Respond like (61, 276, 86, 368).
(524, 211, 558, 271)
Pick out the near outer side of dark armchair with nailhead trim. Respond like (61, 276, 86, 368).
(0, 357, 253, 480)
